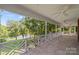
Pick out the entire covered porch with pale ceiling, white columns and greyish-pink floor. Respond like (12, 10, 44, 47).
(0, 4, 79, 55)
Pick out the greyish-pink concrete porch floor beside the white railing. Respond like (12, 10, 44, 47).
(21, 35, 79, 55)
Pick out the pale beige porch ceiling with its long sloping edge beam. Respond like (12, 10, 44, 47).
(0, 4, 79, 26)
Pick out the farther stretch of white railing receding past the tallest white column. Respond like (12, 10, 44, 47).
(36, 32, 62, 46)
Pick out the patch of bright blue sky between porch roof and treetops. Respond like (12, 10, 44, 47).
(0, 10, 24, 25)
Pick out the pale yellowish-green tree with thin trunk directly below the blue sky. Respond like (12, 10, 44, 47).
(7, 20, 19, 40)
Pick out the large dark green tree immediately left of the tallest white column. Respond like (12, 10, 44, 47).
(24, 18, 45, 36)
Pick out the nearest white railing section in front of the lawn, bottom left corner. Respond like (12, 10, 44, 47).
(0, 40, 24, 55)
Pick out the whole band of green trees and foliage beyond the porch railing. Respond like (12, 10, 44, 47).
(0, 17, 74, 42)
